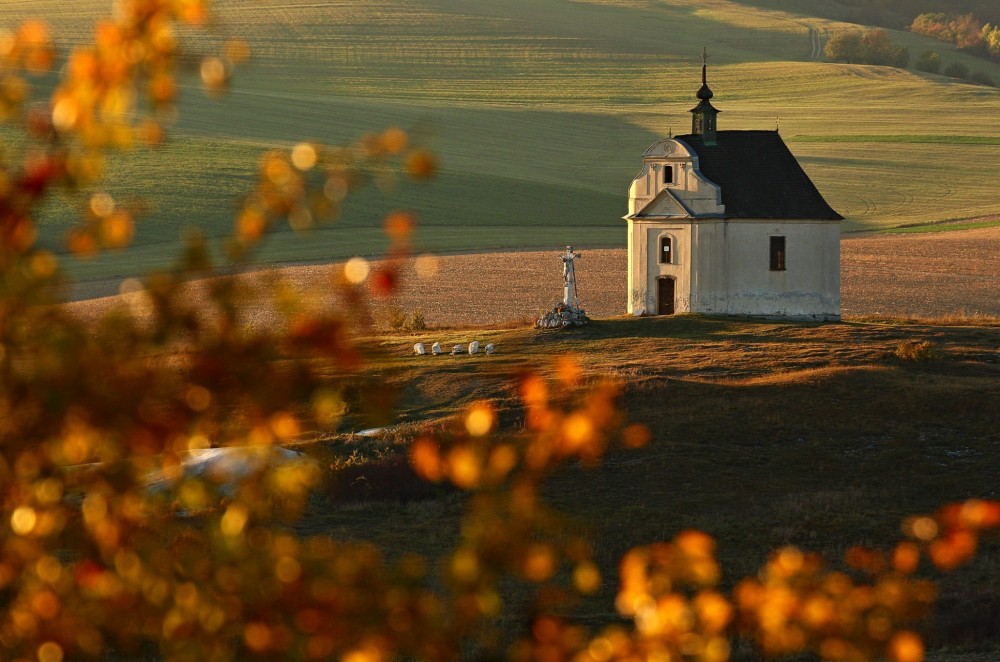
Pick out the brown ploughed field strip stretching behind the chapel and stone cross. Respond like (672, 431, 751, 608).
(72, 227, 1000, 326)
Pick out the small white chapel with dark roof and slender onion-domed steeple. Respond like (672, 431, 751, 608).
(625, 55, 843, 320)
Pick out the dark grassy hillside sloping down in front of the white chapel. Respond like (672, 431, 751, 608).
(301, 316, 1000, 662)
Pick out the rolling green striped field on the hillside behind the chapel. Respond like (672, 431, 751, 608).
(0, 0, 1000, 290)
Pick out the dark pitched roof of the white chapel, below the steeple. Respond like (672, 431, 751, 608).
(675, 131, 843, 221)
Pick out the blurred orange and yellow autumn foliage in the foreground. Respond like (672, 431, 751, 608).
(0, 0, 1000, 662)
